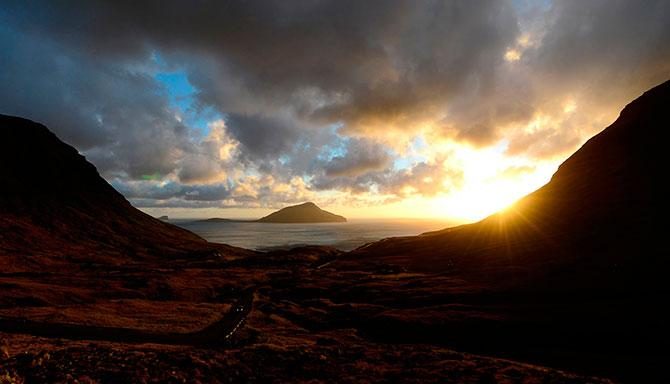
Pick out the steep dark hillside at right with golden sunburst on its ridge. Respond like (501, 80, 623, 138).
(349, 82, 670, 290)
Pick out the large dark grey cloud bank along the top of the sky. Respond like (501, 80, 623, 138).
(1, 1, 518, 142)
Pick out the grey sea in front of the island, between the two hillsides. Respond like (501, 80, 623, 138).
(175, 219, 452, 251)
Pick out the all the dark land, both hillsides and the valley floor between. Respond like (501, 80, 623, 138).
(0, 83, 670, 383)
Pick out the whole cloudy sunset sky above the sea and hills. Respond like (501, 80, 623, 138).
(0, 0, 670, 222)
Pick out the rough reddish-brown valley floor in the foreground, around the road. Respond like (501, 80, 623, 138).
(0, 248, 608, 383)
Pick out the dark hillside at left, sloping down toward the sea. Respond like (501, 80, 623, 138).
(0, 115, 226, 271)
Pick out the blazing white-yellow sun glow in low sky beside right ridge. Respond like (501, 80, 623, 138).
(322, 142, 559, 224)
